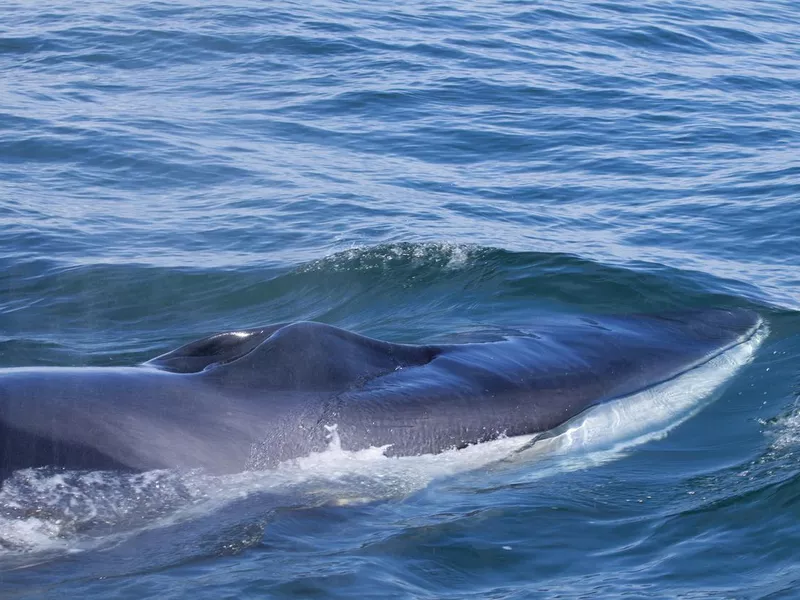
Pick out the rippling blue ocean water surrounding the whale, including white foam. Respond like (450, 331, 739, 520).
(0, 0, 800, 599)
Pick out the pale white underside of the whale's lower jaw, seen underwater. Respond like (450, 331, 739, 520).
(524, 320, 769, 455)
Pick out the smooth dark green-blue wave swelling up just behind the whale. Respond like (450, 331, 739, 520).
(0, 243, 772, 366)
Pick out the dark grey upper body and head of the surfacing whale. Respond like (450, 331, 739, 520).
(0, 309, 761, 479)
